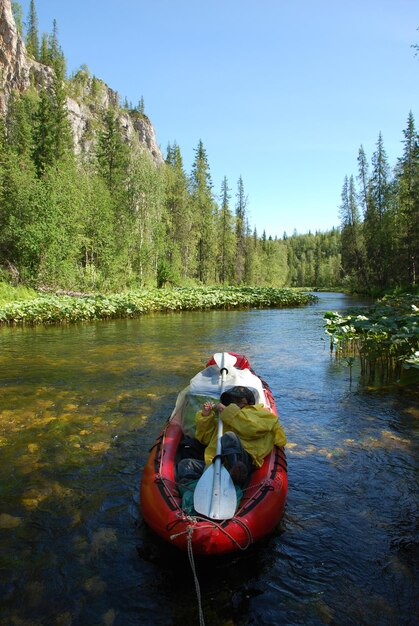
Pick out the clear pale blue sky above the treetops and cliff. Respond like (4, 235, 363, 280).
(21, 0, 419, 237)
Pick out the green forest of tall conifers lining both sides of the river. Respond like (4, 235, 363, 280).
(0, 1, 419, 293)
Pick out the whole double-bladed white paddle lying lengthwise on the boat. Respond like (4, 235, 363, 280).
(194, 352, 237, 519)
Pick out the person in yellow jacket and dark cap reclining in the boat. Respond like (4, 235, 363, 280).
(179, 387, 287, 486)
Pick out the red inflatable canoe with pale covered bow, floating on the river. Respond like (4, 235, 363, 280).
(140, 353, 288, 555)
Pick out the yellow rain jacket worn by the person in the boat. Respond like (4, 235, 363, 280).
(195, 404, 287, 467)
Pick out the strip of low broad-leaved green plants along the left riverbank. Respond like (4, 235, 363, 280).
(0, 287, 316, 325)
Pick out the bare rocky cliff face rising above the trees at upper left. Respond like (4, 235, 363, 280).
(0, 0, 164, 165)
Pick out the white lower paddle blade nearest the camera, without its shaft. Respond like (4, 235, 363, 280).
(194, 462, 237, 519)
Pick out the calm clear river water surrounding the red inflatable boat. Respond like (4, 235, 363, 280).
(0, 293, 419, 626)
